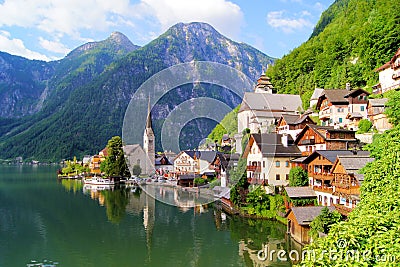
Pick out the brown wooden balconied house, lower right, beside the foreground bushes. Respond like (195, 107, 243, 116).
(332, 154, 374, 216)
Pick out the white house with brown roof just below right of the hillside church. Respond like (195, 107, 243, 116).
(276, 114, 315, 139)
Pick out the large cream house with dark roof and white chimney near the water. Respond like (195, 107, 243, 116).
(243, 133, 301, 190)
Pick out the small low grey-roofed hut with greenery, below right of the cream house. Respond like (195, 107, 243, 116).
(285, 186, 317, 210)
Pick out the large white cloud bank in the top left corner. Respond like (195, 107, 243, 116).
(0, 0, 133, 39)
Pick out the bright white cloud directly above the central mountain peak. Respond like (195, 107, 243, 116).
(138, 0, 243, 38)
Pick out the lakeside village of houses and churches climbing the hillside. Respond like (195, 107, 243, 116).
(60, 46, 400, 247)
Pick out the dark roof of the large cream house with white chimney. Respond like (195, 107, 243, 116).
(252, 133, 301, 157)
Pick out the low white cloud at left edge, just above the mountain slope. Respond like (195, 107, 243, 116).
(0, 31, 50, 61)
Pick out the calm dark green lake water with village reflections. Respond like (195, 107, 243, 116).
(0, 165, 300, 267)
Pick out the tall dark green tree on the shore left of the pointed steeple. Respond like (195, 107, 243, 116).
(100, 136, 130, 177)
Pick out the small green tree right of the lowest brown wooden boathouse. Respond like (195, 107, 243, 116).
(310, 207, 342, 239)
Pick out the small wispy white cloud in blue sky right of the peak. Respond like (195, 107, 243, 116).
(267, 10, 313, 33)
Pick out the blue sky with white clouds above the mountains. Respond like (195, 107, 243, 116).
(0, 0, 334, 61)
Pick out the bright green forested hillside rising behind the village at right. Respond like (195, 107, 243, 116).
(267, 0, 400, 105)
